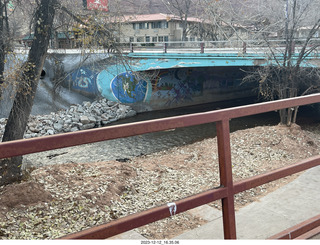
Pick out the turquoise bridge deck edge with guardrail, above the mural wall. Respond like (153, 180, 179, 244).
(127, 40, 320, 71)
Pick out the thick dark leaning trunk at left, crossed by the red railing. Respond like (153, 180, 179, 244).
(0, 0, 55, 185)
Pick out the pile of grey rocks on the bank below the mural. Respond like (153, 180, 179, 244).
(0, 99, 136, 138)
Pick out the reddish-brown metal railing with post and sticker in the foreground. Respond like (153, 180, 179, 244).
(0, 93, 320, 239)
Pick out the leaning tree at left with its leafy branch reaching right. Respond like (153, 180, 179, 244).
(0, 0, 129, 185)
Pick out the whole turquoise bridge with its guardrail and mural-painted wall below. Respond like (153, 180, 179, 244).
(46, 39, 320, 111)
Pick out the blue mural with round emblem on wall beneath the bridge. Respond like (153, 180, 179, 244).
(67, 67, 252, 110)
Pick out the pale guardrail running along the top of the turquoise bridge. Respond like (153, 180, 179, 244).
(15, 38, 320, 56)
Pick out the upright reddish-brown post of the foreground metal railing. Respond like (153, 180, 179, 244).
(216, 119, 237, 239)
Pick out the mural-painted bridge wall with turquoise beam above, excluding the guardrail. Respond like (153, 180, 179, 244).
(59, 53, 255, 112)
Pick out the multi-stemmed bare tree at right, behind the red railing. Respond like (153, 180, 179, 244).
(245, 0, 320, 126)
